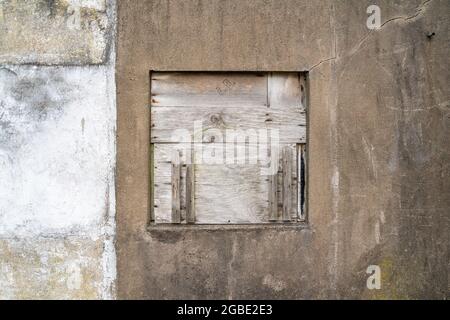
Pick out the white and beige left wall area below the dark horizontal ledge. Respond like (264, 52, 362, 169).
(0, 66, 115, 298)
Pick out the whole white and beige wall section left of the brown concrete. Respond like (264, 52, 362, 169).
(0, 0, 116, 299)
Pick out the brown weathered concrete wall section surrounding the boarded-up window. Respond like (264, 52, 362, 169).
(117, 0, 450, 299)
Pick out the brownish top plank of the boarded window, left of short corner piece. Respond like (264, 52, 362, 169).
(151, 72, 267, 108)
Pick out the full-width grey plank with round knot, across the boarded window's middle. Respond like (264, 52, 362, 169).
(151, 106, 306, 144)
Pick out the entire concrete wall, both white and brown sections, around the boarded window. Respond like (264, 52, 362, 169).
(0, 0, 450, 299)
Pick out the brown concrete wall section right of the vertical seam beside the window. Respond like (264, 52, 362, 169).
(334, 1, 450, 299)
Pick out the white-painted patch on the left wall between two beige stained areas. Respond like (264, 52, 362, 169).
(0, 67, 115, 238)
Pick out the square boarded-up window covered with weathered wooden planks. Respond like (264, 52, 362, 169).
(151, 72, 306, 224)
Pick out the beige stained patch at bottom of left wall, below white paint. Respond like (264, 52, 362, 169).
(0, 236, 104, 299)
